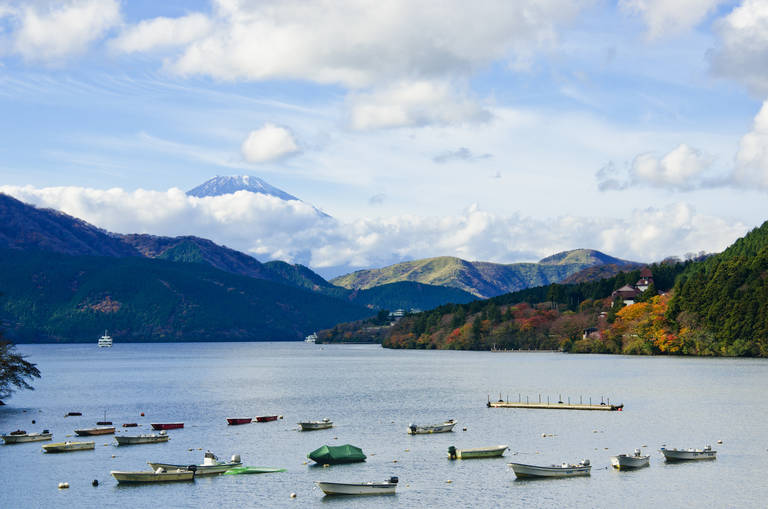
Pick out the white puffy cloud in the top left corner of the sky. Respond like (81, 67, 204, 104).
(11, 0, 121, 62)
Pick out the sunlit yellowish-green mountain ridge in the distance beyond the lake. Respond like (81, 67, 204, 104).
(330, 249, 642, 298)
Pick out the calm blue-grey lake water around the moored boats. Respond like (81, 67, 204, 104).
(0, 342, 768, 508)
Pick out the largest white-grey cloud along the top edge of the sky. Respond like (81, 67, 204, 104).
(114, 0, 591, 88)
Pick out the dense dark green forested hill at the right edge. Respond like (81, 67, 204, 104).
(667, 221, 768, 356)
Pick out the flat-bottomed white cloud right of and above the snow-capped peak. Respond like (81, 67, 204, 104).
(349, 81, 491, 130)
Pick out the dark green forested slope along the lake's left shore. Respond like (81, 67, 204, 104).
(0, 249, 373, 342)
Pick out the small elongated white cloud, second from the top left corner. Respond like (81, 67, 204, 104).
(110, 13, 211, 53)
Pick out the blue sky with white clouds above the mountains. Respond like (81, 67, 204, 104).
(0, 0, 768, 277)
